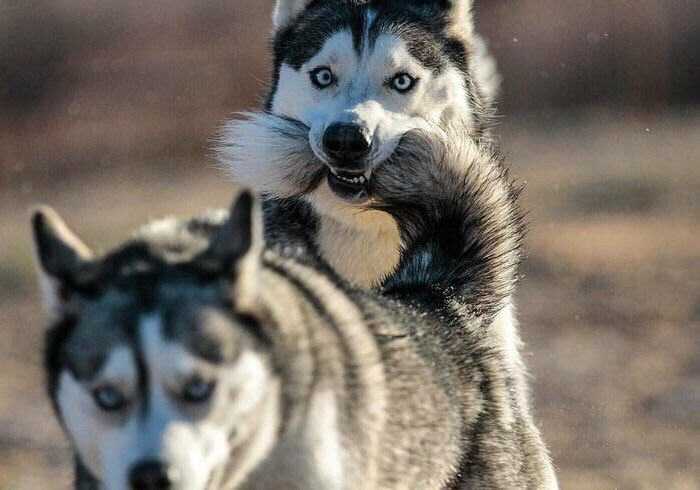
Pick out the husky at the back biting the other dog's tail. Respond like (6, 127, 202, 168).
(220, 0, 499, 288)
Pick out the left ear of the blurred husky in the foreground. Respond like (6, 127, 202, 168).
(32, 206, 93, 318)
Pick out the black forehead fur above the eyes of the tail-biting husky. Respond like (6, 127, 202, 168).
(275, 0, 450, 71)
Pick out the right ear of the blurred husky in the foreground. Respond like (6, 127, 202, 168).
(200, 190, 263, 313)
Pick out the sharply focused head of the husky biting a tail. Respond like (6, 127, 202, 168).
(219, 0, 496, 211)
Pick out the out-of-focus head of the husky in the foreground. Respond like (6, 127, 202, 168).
(33, 193, 278, 490)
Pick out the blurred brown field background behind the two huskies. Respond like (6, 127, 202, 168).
(0, 0, 700, 490)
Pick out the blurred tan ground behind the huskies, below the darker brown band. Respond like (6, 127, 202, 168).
(0, 115, 700, 490)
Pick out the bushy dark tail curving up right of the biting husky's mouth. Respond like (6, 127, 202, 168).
(373, 130, 523, 317)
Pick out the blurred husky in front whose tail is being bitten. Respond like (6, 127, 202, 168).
(33, 132, 556, 490)
